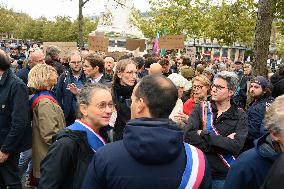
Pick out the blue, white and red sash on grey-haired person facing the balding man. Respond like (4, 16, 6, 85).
(67, 120, 106, 152)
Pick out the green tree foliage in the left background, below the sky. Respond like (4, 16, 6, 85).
(0, 4, 98, 42)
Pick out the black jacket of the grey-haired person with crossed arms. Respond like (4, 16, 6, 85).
(184, 103, 248, 179)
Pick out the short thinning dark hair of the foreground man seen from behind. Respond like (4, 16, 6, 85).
(135, 75, 178, 118)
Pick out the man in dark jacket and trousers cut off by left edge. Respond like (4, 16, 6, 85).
(0, 50, 31, 189)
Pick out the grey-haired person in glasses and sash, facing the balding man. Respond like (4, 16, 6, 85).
(38, 84, 114, 189)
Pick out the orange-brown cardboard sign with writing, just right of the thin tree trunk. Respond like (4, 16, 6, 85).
(88, 36, 109, 52)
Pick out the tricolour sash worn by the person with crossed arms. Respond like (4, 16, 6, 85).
(202, 101, 236, 168)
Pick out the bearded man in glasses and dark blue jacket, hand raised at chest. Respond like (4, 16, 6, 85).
(56, 51, 86, 125)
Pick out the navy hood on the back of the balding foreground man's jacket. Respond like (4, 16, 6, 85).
(123, 118, 183, 164)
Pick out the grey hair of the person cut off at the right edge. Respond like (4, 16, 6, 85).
(264, 95, 284, 133)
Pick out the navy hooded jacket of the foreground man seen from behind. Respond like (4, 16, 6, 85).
(82, 118, 211, 189)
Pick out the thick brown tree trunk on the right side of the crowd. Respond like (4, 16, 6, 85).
(252, 0, 276, 78)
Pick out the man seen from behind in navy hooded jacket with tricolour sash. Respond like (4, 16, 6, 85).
(82, 75, 211, 189)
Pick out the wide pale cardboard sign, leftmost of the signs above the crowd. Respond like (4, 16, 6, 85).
(43, 42, 78, 58)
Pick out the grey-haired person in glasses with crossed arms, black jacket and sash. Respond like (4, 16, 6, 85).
(184, 71, 248, 189)
